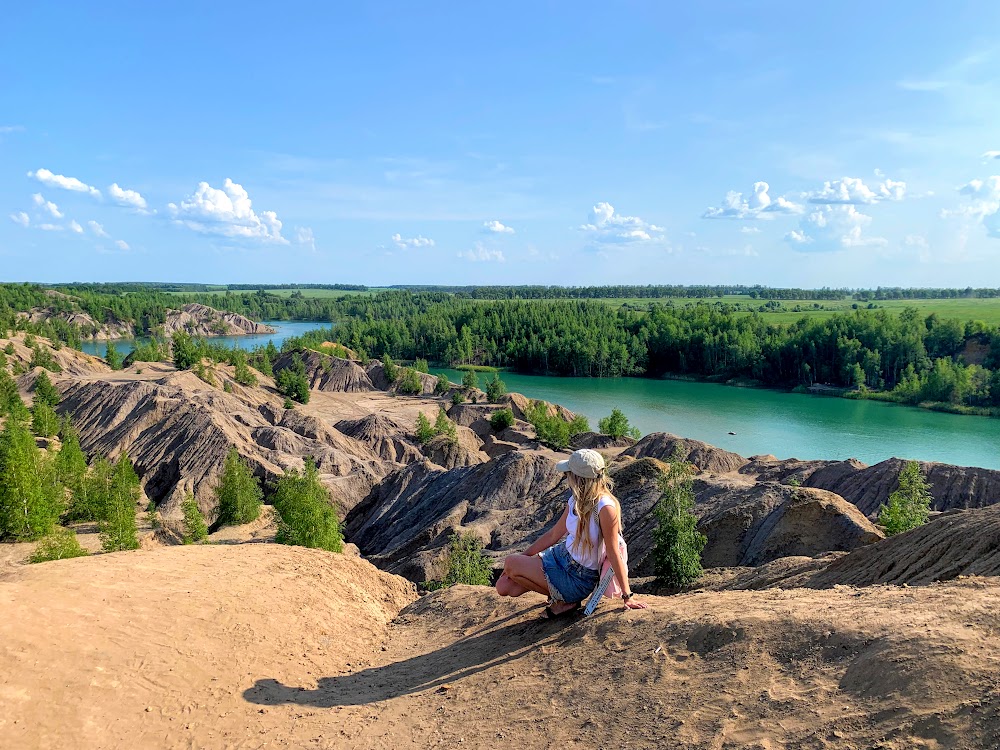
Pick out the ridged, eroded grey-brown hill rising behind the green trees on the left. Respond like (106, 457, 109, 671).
(56, 372, 392, 519)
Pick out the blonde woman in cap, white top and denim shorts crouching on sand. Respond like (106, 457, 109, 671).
(497, 448, 646, 618)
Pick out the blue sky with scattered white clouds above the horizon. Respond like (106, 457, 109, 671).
(0, 0, 1000, 287)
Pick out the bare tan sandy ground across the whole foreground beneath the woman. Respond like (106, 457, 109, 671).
(0, 544, 1000, 750)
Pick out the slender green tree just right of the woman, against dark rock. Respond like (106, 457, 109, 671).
(653, 456, 708, 588)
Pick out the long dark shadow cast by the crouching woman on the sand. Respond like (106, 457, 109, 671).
(243, 611, 579, 708)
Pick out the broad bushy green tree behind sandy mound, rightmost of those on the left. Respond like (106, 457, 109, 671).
(272, 458, 344, 552)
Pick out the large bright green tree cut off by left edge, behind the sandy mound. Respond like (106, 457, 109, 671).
(0, 419, 62, 542)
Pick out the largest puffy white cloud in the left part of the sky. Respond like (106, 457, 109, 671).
(167, 177, 288, 245)
